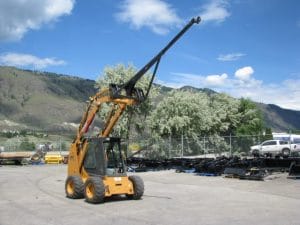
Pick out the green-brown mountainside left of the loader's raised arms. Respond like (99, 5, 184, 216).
(0, 67, 96, 130)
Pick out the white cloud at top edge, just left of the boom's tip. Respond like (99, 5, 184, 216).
(116, 0, 182, 34)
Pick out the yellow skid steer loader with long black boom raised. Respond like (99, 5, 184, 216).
(65, 17, 201, 203)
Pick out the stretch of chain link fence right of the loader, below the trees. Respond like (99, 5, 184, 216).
(128, 135, 262, 159)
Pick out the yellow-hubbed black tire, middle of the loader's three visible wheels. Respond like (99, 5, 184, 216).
(84, 177, 105, 204)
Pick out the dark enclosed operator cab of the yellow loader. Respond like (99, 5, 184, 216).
(83, 137, 126, 176)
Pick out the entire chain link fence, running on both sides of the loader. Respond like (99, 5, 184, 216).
(0, 135, 298, 159)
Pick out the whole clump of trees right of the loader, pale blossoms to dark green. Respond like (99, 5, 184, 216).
(149, 90, 262, 156)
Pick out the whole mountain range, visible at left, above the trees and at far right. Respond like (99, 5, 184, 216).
(0, 66, 300, 131)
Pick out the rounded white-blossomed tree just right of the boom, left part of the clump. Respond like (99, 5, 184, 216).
(149, 90, 213, 137)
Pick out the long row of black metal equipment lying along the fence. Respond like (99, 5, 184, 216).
(127, 156, 300, 180)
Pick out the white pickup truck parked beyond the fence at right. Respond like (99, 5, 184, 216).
(250, 140, 300, 157)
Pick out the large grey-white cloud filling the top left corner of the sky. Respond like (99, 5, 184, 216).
(0, 0, 75, 41)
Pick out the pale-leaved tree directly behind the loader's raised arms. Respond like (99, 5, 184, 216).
(97, 64, 159, 138)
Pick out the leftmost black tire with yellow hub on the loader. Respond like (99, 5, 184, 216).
(65, 176, 83, 199)
